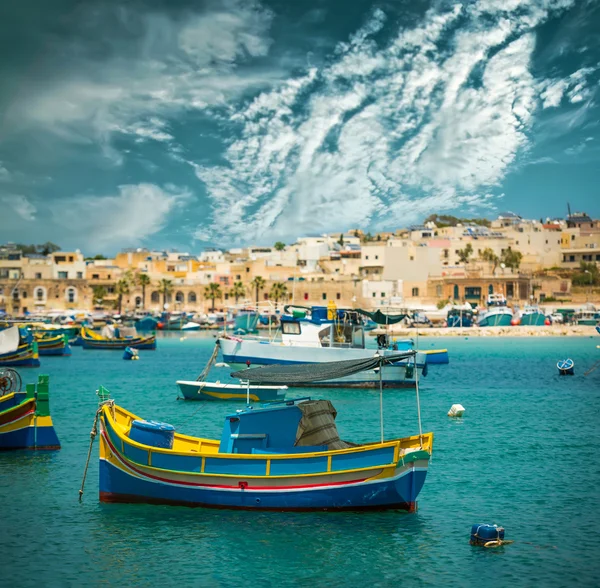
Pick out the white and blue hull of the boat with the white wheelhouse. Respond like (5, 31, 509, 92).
(219, 339, 427, 388)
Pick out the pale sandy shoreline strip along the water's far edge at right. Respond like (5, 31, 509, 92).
(369, 325, 600, 343)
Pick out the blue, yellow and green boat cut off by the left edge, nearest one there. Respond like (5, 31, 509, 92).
(0, 368, 60, 450)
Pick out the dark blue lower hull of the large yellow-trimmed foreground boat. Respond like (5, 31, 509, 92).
(100, 460, 427, 511)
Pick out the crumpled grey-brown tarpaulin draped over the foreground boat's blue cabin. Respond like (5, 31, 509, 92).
(294, 400, 355, 450)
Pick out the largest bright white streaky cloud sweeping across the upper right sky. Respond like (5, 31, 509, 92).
(192, 0, 569, 240)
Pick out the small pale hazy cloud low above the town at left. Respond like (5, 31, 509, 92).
(52, 184, 191, 250)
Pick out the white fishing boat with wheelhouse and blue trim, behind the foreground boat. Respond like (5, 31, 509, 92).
(217, 305, 427, 388)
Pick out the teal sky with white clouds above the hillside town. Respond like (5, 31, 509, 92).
(0, 0, 600, 255)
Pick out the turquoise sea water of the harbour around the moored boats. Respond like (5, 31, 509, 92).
(0, 334, 600, 587)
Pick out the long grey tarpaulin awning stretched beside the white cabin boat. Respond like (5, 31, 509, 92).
(231, 351, 415, 384)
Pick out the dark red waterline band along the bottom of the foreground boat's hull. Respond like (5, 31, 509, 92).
(100, 492, 417, 512)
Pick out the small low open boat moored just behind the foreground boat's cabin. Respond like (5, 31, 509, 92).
(177, 380, 288, 402)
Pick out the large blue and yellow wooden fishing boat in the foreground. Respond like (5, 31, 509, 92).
(98, 358, 433, 511)
